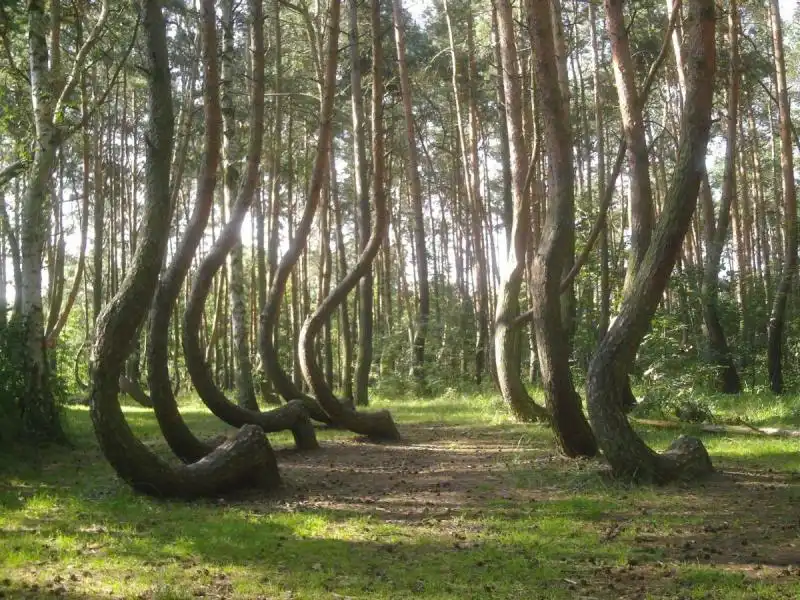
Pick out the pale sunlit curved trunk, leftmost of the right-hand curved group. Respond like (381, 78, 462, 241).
(494, 0, 549, 421)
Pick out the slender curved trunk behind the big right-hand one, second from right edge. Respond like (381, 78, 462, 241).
(702, 0, 742, 394)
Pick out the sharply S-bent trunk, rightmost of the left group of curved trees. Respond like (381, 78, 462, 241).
(298, 0, 400, 440)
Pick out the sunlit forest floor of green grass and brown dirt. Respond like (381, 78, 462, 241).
(0, 393, 800, 600)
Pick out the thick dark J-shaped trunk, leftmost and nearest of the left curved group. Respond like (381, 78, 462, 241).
(90, 0, 280, 498)
